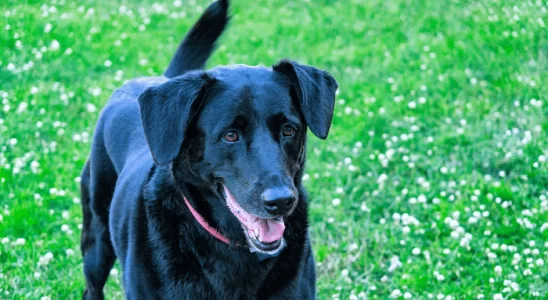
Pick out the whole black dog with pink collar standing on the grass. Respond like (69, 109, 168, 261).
(81, 1, 337, 299)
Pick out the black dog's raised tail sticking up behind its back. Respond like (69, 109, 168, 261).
(164, 0, 230, 78)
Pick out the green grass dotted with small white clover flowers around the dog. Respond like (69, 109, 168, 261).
(0, 0, 548, 299)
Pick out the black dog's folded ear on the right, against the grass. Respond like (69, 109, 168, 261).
(272, 60, 338, 139)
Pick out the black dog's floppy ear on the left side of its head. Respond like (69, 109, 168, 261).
(139, 72, 214, 165)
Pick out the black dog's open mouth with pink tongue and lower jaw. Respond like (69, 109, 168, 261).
(223, 186, 285, 254)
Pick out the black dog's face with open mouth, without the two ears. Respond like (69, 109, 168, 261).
(190, 68, 306, 251)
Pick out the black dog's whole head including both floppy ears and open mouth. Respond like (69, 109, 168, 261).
(139, 61, 337, 253)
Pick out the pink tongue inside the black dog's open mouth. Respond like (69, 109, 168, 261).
(224, 186, 285, 243)
